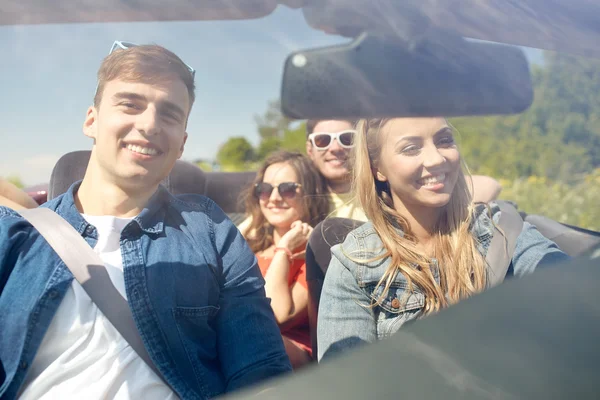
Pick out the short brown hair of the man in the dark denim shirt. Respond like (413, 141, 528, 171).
(94, 45, 196, 110)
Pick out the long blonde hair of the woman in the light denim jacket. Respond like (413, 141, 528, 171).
(352, 119, 486, 314)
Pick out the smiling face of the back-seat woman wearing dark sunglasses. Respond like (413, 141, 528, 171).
(259, 163, 304, 230)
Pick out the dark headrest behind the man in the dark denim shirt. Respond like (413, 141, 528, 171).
(48, 150, 206, 200)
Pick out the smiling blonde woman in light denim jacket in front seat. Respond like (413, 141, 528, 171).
(317, 118, 567, 360)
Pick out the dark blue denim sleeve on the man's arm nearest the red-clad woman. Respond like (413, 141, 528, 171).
(210, 202, 291, 392)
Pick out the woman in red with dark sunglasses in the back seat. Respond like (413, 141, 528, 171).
(242, 151, 329, 368)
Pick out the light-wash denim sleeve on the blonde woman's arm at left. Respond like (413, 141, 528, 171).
(317, 241, 377, 362)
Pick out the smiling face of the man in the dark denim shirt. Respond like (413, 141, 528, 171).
(84, 79, 190, 188)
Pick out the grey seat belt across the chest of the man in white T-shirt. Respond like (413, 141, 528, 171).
(17, 207, 177, 393)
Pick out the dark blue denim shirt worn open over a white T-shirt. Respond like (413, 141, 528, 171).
(0, 183, 291, 399)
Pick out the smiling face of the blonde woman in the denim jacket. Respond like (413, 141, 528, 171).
(375, 118, 460, 211)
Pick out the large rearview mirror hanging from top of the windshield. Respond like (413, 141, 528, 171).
(281, 33, 533, 119)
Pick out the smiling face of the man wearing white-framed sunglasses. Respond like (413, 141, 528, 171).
(306, 120, 353, 186)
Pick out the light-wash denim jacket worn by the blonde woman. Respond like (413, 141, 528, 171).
(317, 203, 568, 360)
